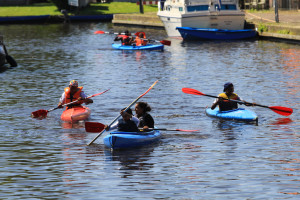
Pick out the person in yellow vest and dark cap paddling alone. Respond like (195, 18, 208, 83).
(211, 82, 252, 111)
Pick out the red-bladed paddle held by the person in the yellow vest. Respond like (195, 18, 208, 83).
(182, 88, 293, 116)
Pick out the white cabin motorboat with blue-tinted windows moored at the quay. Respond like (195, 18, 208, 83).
(157, 0, 245, 37)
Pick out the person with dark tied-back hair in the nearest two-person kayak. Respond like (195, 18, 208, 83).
(135, 102, 154, 129)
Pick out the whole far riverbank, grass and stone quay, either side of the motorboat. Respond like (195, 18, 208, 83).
(0, 2, 300, 41)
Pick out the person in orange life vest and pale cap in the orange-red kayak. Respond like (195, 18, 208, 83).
(58, 80, 93, 109)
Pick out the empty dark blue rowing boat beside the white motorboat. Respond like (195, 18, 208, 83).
(176, 27, 257, 40)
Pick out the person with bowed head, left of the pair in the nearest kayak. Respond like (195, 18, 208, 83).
(105, 108, 139, 132)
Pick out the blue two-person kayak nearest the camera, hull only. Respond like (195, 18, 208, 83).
(103, 130, 161, 149)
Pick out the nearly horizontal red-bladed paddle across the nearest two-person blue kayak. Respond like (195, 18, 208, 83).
(85, 122, 199, 133)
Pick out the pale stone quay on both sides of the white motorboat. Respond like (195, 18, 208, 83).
(112, 11, 300, 41)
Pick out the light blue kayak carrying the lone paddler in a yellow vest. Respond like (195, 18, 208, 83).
(205, 107, 258, 122)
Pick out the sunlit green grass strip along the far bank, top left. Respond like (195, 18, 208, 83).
(0, 2, 157, 17)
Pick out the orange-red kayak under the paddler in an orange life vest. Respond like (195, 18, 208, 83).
(60, 106, 91, 122)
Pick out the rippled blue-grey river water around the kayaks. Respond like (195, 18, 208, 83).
(0, 23, 300, 200)
